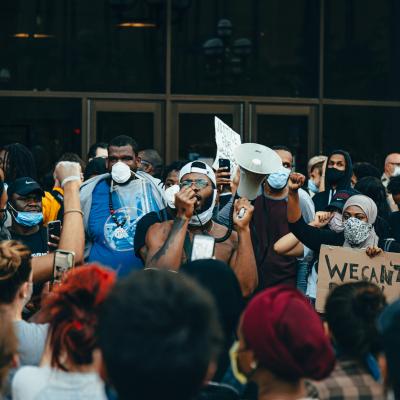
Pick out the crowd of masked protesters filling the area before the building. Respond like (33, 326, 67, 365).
(0, 135, 400, 400)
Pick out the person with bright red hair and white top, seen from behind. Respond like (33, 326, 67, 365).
(12, 264, 115, 400)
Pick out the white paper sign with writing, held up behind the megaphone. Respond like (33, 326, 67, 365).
(213, 117, 242, 175)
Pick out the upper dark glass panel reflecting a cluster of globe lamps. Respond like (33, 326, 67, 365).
(172, 0, 319, 97)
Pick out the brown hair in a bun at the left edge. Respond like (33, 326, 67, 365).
(0, 240, 32, 304)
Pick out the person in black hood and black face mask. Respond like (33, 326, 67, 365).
(313, 150, 353, 212)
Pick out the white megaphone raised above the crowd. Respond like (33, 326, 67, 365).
(234, 143, 282, 200)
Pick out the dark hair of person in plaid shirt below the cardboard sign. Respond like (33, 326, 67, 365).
(325, 282, 386, 360)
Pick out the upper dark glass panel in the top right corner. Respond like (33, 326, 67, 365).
(324, 0, 400, 100)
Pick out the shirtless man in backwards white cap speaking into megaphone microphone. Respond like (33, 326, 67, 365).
(141, 161, 258, 297)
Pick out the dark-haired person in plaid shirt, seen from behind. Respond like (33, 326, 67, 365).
(308, 281, 386, 400)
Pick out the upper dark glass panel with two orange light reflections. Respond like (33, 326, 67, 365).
(0, 0, 165, 92)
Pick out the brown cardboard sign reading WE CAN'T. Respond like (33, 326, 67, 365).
(316, 245, 400, 313)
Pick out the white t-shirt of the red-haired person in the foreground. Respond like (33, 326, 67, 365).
(12, 366, 107, 400)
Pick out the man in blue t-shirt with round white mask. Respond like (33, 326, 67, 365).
(81, 135, 165, 276)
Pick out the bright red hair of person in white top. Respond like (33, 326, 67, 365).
(42, 264, 115, 371)
